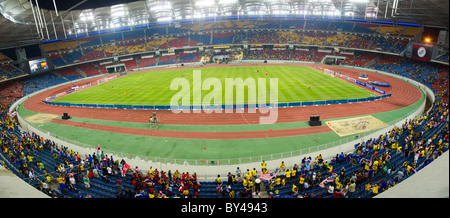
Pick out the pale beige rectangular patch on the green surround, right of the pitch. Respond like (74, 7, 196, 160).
(327, 115, 387, 136)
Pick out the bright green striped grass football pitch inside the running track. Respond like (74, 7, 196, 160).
(53, 66, 375, 105)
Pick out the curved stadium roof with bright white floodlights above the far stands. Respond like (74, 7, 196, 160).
(0, 0, 449, 48)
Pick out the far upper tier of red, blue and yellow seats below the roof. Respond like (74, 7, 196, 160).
(42, 20, 418, 70)
